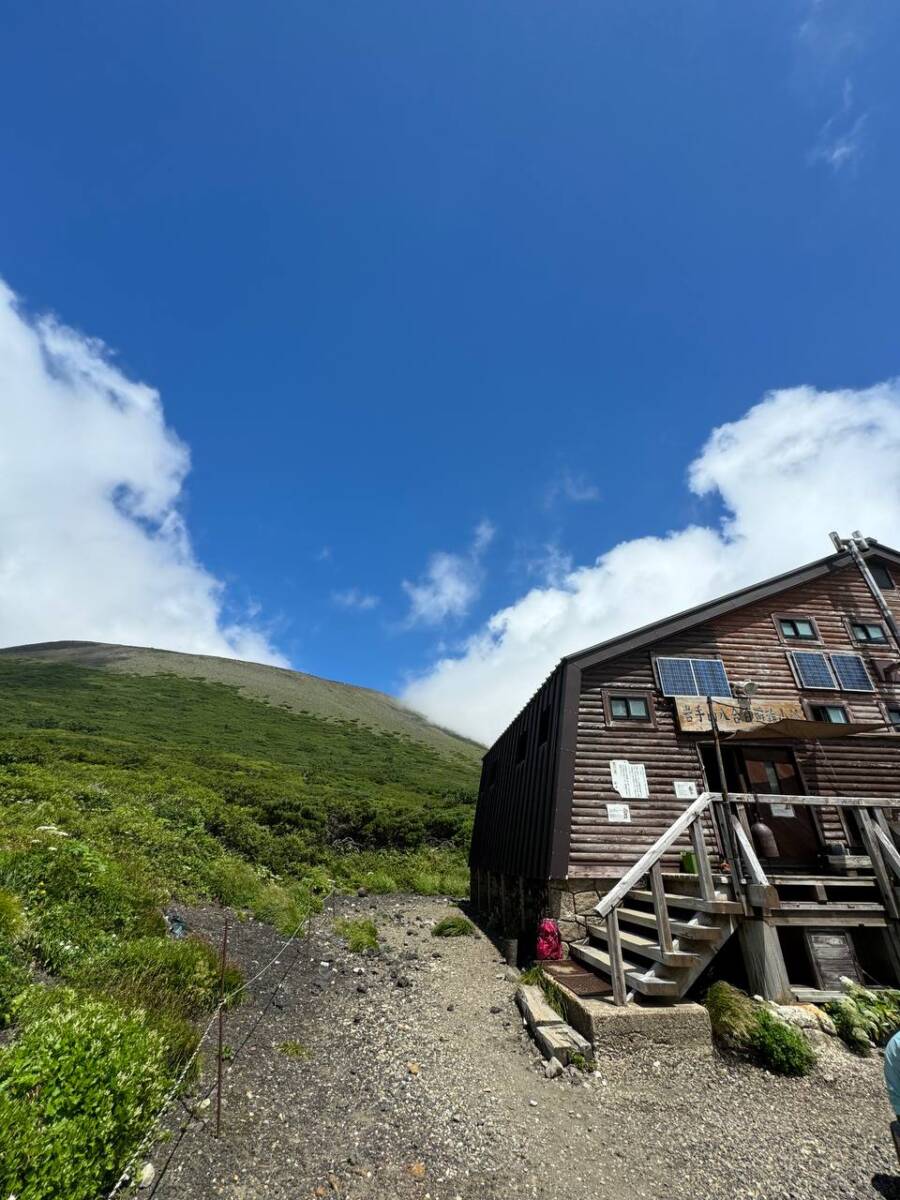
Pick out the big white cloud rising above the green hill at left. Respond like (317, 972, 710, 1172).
(0, 281, 287, 665)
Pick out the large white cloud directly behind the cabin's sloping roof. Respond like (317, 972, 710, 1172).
(403, 380, 900, 742)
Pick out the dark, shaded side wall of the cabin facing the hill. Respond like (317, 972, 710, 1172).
(469, 665, 565, 880)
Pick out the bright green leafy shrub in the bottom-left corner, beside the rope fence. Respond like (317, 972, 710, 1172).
(0, 985, 172, 1200)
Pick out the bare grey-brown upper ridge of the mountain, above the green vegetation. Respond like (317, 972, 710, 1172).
(0, 642, 485, 761)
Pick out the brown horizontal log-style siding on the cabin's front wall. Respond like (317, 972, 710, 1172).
(569, 566, 900, 877)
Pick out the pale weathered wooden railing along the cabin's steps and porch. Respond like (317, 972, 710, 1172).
(595, 792, 900, 1004)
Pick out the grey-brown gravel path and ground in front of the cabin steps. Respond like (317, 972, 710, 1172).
(139, 896, 900, 1200)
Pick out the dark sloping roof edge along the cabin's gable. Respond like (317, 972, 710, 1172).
(562, 538, 900, 668)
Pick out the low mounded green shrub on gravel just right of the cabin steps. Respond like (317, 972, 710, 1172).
(704, 982, 816, 1075)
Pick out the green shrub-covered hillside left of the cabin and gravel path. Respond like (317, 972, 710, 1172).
(0, 654, 478, 1200)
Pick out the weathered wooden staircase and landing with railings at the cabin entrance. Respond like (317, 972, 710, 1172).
(570, 792, 900, 1004)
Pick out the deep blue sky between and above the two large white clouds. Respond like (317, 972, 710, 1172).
(0, 0, 900, 731)
